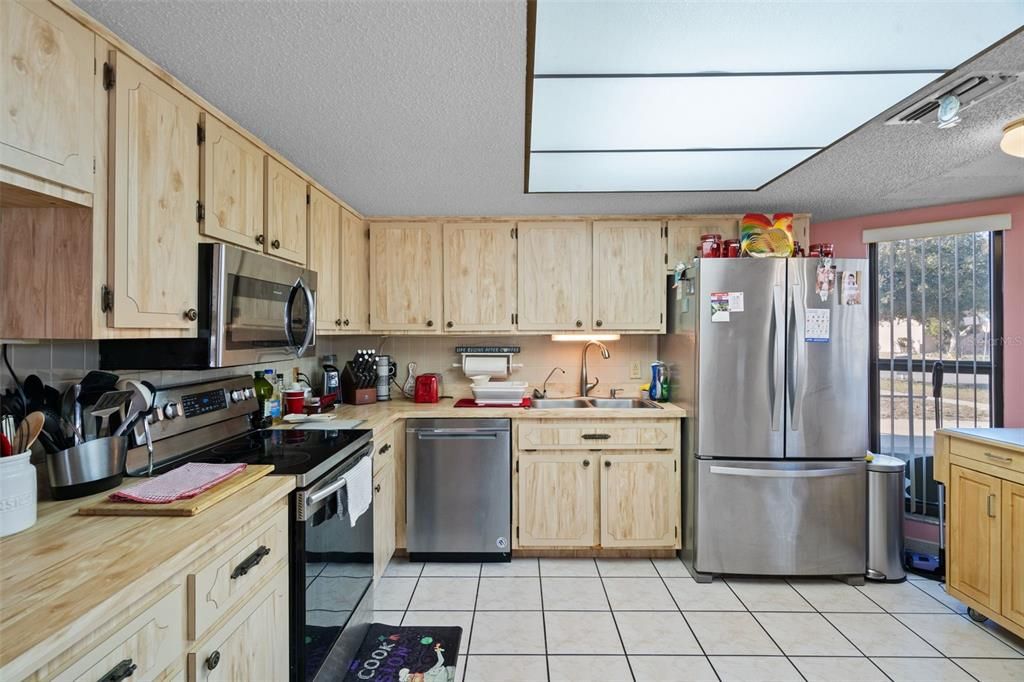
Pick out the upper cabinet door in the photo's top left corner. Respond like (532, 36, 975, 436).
(0, 0, 96, 191)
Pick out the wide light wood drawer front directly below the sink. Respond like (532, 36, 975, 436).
(518, 419, 679, 451)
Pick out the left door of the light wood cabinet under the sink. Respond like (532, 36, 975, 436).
(518, 453, 599, 548)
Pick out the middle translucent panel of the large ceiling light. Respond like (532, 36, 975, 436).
(530, 74, 936, 152)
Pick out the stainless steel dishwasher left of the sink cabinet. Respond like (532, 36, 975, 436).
(406, 419, 512, 561)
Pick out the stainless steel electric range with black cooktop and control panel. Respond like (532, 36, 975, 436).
(126, 377, 374, 681)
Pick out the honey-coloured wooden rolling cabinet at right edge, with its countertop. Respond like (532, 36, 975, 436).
(935, 429, 1024, 637)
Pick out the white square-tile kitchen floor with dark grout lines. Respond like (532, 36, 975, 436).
(375, 559, 1024, 682)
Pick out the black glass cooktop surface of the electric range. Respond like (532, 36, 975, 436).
(174, 429, 371, 486)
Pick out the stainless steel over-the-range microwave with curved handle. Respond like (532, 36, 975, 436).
(99, 244, 316, 370)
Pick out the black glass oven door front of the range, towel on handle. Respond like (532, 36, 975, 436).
(292, 443, 374, 680)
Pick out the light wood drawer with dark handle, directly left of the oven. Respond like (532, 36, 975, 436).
(187, 507, 288, 640)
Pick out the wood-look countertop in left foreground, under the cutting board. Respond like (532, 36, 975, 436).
(0, 475, 295, 680)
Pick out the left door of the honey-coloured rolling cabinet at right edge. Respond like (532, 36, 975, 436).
(948, 465, 1000, 611)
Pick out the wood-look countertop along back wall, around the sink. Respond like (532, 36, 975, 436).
(275, 398, 686, 429)
